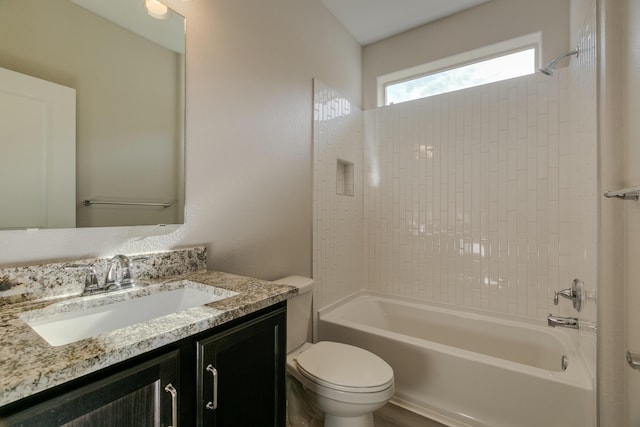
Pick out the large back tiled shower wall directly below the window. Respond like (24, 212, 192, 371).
(364, 68, 570, 319)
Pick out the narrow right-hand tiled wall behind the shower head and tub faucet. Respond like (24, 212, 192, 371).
(560, 1, 602, 378)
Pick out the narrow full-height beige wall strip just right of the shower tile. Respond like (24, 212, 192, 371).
(598, 0, 638, 427)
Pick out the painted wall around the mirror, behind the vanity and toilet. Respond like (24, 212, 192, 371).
(0, 0, 361, 279)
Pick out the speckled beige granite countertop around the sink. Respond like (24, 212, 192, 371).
(0, 253, 297, 406)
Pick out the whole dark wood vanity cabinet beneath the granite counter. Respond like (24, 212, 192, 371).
(0, 303, 286, 427)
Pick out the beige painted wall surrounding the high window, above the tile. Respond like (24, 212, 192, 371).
(362, 0, 569, 110)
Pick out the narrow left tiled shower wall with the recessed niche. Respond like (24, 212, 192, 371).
(313, 80, 364, 308)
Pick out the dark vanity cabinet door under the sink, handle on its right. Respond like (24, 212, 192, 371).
(0, 351, 179, 427)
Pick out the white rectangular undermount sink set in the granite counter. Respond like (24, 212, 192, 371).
(21, 280, 237, 346)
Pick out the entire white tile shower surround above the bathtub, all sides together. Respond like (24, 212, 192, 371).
(313, 37, 597, 328)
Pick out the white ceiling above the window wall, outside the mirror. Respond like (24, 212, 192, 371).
(322, 0, 489, 46)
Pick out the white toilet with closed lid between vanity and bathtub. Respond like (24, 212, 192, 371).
(275, 276, 395, 427)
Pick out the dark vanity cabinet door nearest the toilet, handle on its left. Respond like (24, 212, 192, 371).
(196, 309, 286, 427)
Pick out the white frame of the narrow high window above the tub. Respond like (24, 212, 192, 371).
(377, 32, 542, 107)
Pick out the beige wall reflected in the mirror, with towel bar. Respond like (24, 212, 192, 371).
(0, 0, 183, 227)
